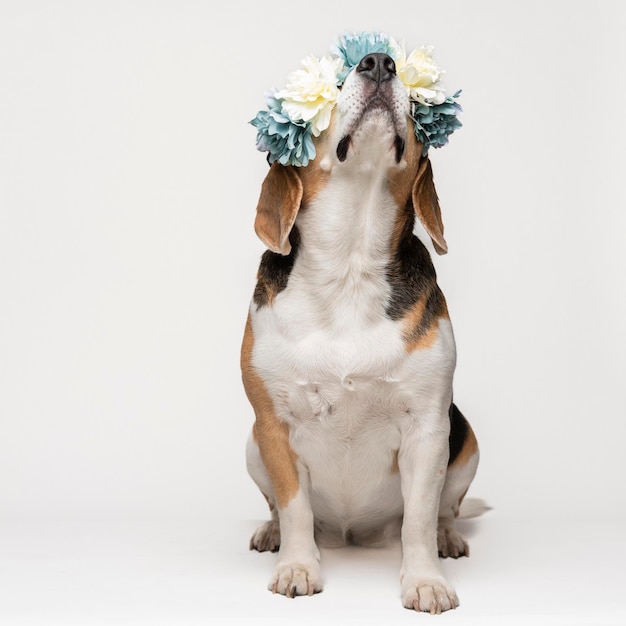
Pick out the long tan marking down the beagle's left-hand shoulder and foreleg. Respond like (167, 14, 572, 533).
(241, 316, 299, 508)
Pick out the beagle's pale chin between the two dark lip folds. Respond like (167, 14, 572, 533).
(336, 107, 406, 165)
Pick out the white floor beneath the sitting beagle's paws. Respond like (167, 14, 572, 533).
(0, 511, 626, 626)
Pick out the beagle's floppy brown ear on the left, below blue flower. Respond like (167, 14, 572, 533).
(254, 163, 303, 255)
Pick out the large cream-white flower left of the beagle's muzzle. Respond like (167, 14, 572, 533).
(276, 56, 343, 137)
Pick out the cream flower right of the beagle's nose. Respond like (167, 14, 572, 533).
(396, 45, 446, 105)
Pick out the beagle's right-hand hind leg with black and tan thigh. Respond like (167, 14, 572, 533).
(437, 404, 479, 559)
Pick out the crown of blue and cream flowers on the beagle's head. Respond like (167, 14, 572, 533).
(250, 32, 461, 166)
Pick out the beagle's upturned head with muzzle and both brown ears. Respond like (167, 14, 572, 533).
(249, 37, 458, 255)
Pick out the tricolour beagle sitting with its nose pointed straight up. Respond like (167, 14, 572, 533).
(241, 53, 478, 613)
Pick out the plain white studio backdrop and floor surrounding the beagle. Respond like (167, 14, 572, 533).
(0, 0, 626, 624)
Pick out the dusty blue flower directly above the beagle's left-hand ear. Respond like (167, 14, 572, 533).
(250, 92, 315, 167)
